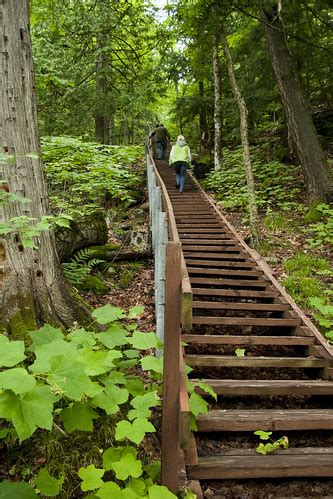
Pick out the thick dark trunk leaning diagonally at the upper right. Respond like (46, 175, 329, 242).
(261, 9, 333, 202)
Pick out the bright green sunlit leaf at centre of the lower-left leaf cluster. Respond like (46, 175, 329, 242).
(47, 355, 95, 400)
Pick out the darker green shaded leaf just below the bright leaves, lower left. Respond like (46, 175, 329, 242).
(59, 402, 99, 433)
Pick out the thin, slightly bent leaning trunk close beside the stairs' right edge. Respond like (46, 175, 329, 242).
(221, 27, 258, 246)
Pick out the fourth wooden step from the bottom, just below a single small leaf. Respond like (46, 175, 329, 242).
(184, 354, 333, 369)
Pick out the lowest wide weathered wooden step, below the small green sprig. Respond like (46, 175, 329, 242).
(186, 447, 333, 480)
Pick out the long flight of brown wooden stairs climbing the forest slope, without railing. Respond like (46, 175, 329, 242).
(157, 162, 333, 495)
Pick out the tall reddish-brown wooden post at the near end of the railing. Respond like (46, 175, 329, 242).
(162, 241, 181, 494)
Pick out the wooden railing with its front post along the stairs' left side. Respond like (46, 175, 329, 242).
(147, 143, 192, 493)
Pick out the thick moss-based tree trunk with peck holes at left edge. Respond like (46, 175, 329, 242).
(0, 0, 89, 337)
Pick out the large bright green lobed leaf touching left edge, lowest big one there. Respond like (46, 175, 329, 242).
(0, 385, 57, 442)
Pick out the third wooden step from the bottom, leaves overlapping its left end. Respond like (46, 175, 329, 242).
(191, 379, 333, 397)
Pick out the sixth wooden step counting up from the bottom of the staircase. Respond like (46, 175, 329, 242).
(192, 315, 302, 327)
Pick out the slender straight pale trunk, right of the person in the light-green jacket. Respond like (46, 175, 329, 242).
(213, 32, 222, 170)
